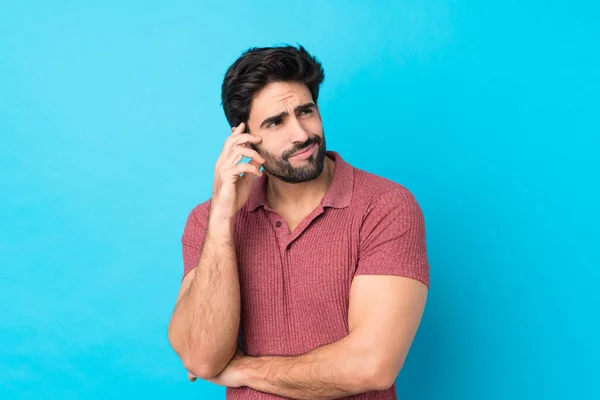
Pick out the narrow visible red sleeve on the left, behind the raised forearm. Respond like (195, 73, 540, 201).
(181, 200, 210, 280)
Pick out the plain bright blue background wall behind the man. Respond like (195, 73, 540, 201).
(0, 0, 600, 399)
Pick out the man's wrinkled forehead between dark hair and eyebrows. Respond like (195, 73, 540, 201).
(250, 82, 313, 119)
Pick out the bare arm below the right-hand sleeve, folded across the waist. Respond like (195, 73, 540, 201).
(208, 275, 427, 399)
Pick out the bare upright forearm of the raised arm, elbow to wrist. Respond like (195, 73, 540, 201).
(169, 216, 240, 378)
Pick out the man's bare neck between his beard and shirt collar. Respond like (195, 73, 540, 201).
(266, 157, 334, 211)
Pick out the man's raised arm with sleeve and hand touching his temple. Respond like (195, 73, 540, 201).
(169, 123, 265, 379)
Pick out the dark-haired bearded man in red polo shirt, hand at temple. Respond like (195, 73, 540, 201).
(169, 46, 429, 400)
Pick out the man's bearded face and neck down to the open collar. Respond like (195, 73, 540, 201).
(248, 82, 334, 231)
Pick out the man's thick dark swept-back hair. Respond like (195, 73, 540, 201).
(221, 45, 325, 127)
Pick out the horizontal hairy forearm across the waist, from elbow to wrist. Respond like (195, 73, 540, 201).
(238, 336, 385, 399)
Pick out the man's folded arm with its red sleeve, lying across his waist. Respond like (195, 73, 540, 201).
(211, 187, 429, 399)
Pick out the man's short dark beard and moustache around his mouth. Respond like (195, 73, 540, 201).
(251, 133, 326, 183)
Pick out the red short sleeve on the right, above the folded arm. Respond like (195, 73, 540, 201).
(354, 185, 429, 287)
